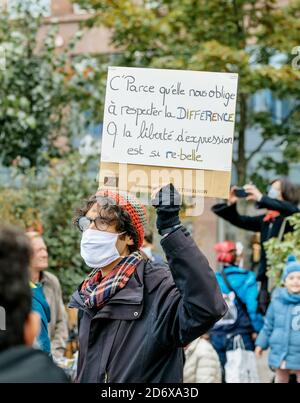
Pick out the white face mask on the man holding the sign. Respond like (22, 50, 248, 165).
(80, 229, 123, 269)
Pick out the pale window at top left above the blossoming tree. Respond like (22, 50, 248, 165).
(7, 0, 51, 18)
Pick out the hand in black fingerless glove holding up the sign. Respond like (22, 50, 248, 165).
(152, 183, 181, 235)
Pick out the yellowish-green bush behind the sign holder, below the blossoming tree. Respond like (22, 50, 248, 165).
(0, 153, 98, 300)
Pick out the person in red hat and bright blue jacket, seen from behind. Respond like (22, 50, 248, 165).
(210, 241, 263, 376)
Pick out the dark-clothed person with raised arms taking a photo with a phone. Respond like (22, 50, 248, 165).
(212, 178, 299, 314)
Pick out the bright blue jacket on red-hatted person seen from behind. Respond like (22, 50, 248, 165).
(216, 266, 263, 332)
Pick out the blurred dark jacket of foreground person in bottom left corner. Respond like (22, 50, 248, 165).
(0, 346, 69, 383)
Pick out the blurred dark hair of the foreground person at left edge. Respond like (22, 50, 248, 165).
(0, 226, 32, 351)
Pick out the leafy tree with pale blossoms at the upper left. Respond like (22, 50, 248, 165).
(0, 2, 103, 166)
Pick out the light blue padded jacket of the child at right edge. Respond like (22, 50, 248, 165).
(256, 288, 300, 369)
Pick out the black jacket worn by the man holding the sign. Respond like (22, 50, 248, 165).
(70, 228, 227, 383)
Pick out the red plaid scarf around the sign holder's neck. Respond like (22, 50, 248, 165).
(80, 251, 143, 309)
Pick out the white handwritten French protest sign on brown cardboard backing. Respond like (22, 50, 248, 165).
(100, 67, 238, 198)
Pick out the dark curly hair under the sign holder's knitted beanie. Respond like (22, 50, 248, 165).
(73, 195, 139, 253)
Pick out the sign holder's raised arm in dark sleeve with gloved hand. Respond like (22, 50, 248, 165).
(153, 185, 227, 346)
